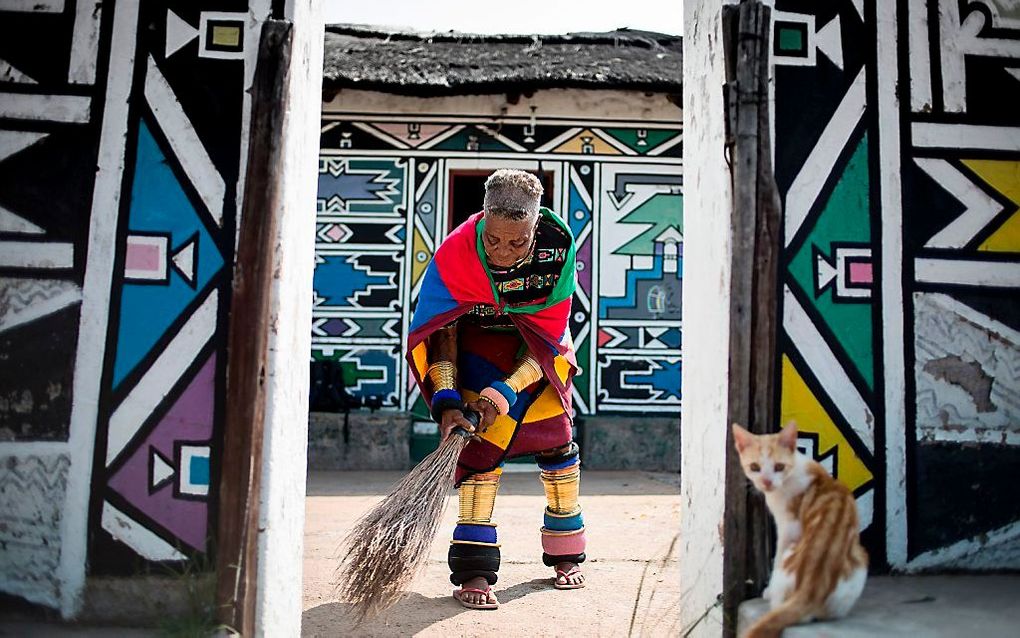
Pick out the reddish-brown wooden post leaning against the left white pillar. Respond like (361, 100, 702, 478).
(216, 20, 293, 636)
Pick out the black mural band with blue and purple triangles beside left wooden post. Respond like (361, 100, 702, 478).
(84, 1, 259, 573)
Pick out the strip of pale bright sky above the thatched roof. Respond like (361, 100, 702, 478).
(322, 0, 683, 35)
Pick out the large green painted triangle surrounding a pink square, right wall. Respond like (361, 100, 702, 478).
(788, 135, 875, 390)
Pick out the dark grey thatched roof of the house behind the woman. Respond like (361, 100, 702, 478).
(322, 24, 682, 96)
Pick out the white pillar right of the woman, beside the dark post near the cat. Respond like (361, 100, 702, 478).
(679, 0, 732, 637)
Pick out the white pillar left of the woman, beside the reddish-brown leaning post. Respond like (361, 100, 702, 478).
(255, 0, 323, 638)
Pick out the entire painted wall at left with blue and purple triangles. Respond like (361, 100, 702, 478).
(0, 0, 269, 614)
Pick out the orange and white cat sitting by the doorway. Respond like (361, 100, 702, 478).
(733, 423, 868, 638)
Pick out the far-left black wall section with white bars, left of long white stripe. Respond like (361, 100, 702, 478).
(0, 2, 106, 606)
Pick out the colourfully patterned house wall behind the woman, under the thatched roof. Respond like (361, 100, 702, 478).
(312, 91, 683, 416)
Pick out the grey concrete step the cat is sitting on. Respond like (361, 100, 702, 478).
(737, 575, 1020, 638)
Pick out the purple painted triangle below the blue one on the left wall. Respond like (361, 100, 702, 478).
(109, 354, 216, 551)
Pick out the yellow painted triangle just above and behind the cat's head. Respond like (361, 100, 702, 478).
(780, 355, 874, 490)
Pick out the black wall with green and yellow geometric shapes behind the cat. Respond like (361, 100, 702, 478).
(773, 0, 1020, 570)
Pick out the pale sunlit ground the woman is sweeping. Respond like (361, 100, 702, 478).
(302, 472, 680, 638)
